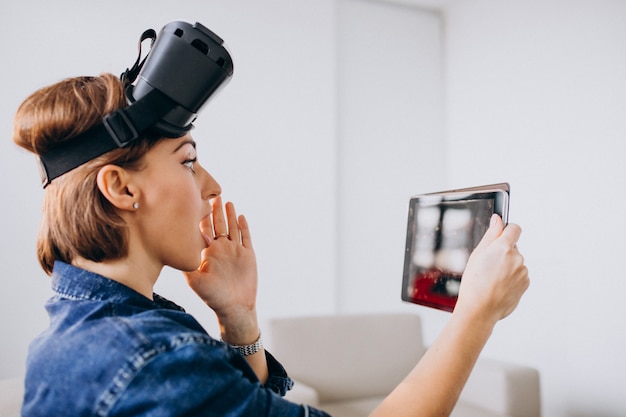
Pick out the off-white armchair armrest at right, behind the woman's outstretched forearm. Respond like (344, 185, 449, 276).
(460, 358, 541, 417)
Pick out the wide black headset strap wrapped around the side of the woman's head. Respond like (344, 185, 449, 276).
(39, 89, 177, 188)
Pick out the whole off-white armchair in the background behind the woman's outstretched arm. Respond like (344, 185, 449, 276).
(268, 314, 541, 417)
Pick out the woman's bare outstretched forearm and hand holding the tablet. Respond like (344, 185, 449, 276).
(371, 215, 529, 417)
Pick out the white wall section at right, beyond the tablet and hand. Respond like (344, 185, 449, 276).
(445, 0, 626, 417)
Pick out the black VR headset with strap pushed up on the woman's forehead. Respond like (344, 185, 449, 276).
(39, 22, 233, 188)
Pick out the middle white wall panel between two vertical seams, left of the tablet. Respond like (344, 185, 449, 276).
(337, 0, 446, 313)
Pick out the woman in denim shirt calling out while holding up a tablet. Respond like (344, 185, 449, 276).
(14, 74, 528, 417)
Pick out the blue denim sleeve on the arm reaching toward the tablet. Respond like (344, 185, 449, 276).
(98, 336, 328, 417)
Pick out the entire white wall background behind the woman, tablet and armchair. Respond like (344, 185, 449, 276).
(0, 0, 626, 417)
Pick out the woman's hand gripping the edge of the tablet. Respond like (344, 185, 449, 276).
(455, 214, 529, 324)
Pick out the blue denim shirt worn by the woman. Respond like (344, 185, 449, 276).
(22, 261, 328, 417)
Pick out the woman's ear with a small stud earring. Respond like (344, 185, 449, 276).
(96, 165, 139, 211)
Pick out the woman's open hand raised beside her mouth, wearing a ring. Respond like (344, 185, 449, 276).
(185, 197, 259, 345)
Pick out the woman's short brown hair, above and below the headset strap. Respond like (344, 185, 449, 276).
(13, 74, 158, 274)
